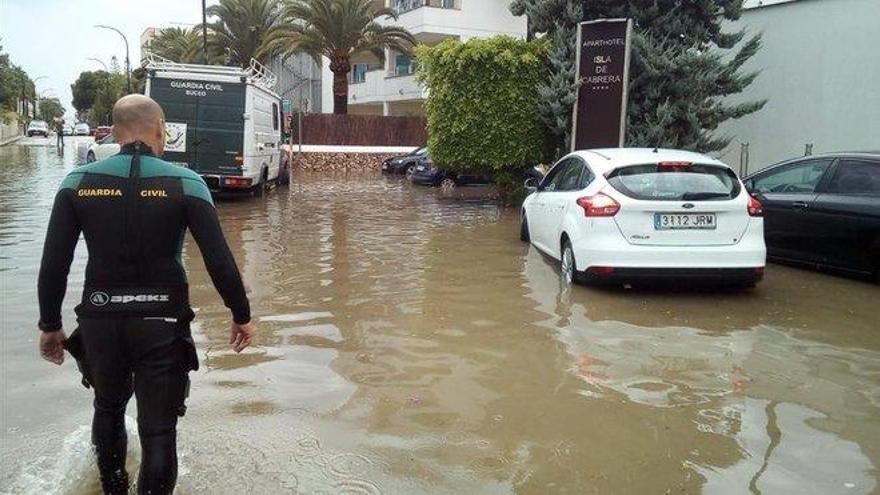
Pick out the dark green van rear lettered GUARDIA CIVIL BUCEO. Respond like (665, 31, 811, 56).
(150, 76, 246, 176)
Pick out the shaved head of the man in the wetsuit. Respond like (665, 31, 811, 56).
(113, 94, 165, 155)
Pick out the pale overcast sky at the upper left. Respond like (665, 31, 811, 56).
(0, 0, 217, 119)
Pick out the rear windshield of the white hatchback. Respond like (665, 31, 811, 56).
(607, 162, 740, 201)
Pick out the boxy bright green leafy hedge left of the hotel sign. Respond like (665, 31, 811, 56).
(416, 36, 548, 198)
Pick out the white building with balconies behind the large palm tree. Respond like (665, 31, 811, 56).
(321, 0, 527, 115)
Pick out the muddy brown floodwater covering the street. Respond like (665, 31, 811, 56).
(0, 137, 880, 494)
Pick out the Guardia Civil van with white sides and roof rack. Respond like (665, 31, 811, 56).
(144, 54, 290, 195)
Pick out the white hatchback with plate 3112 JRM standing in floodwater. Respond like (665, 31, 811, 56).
(520, 148, 767, 286)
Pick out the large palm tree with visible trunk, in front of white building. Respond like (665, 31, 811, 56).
(264, 0, 416, 114)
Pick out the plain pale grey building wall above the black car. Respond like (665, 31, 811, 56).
(719, 0, 880, 171)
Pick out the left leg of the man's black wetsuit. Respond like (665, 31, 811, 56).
(79, 318, 134, 495)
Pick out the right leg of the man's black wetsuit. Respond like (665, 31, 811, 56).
(126, 318, 188, 495)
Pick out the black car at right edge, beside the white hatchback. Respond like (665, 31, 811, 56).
(744, 152, 880, 282)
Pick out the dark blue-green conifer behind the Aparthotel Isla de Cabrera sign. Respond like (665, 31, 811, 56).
(511, 0, 765, 152)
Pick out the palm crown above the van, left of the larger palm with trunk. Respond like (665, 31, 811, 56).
(207, 0, 281, 67)
